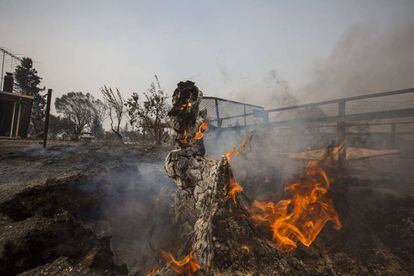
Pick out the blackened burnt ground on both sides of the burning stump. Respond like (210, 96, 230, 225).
(0, 141, 414, 275)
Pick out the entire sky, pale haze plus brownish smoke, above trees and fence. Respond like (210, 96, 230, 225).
(0, 0, 414, 113)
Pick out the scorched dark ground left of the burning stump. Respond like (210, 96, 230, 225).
(0, 141, 178, 275)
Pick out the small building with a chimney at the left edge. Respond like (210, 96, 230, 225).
(0, 73, 33, 138)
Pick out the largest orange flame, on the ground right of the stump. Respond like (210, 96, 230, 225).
(250, 152, 342, 252)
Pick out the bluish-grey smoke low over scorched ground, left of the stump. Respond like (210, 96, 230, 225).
(82, 148, 177, 273)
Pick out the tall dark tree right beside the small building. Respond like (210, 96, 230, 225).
(14, 57, 46, 135)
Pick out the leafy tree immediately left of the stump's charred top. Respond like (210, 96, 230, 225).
(126, 75, 169, 144)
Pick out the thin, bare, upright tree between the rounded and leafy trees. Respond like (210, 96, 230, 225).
(101, 85, 125, 140)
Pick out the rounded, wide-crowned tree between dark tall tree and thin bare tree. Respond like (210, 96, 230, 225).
(55, 92, 103, 138)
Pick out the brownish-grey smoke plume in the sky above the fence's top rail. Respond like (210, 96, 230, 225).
(228, 9, 414, 108)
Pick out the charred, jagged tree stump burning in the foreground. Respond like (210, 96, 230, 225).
(165, 81, 306, 273)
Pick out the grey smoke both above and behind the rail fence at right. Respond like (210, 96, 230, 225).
(206, 15, 414, 202)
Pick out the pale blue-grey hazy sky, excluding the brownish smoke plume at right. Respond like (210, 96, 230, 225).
(0, 0, 414, 110)
